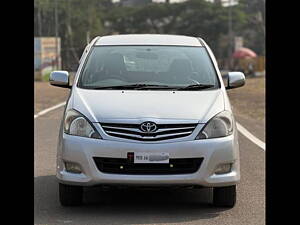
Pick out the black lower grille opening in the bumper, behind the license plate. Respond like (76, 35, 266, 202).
(94, 157, 203, 175)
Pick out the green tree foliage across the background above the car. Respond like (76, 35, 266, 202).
(34, 0, 265, 70)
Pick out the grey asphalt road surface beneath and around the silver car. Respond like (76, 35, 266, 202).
(34, 108, 265, 225)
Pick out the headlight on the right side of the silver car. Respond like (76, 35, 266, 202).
(196, 111, 233, 139)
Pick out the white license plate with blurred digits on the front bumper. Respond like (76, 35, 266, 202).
(134, 152, 169, 163)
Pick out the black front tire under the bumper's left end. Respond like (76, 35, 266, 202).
(59, 183, 83, 206)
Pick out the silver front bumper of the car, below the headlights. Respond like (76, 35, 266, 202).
(57, 134, 240, 187)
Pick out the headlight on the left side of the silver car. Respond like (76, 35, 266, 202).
(64, 109, 101, 139)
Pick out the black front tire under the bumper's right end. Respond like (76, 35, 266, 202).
(213, 185, 236, 208)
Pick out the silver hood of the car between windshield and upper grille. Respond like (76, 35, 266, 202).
(72, 88, 224, 123)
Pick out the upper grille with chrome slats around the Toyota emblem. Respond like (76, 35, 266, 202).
(101, 123, 197, 141)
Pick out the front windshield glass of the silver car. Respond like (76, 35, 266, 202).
(78, 46, 219, 90)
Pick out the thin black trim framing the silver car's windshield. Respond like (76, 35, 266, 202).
(76, 44, 221, 91)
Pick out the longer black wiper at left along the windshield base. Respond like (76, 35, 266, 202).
(86, 84, 174, 90)
